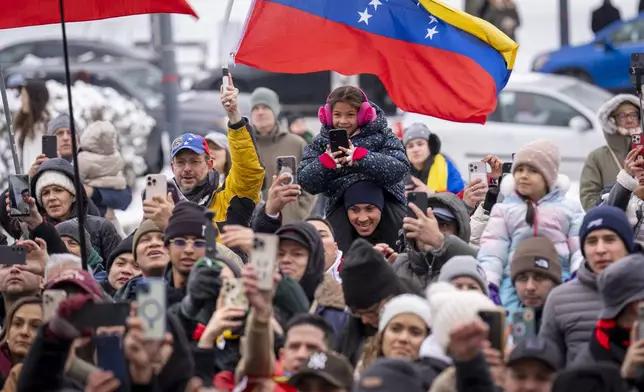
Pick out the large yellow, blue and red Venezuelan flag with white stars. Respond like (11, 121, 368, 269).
(235, 0, 518, 123)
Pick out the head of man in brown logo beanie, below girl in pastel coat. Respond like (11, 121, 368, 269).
(510, 237, 561, 331)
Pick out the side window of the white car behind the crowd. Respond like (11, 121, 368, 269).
(497, 91, 582, 127)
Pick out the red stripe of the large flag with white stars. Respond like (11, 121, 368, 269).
(235, 1, 496, 123)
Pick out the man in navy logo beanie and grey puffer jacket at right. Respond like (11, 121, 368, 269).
(539, 206, 634, 365)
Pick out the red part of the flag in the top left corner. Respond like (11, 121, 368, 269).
(0, 0, 197, 29)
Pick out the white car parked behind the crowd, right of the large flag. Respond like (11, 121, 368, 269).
(402, 73, 612, 181)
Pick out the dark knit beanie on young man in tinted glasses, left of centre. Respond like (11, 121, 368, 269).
(163, 200, 206, 246)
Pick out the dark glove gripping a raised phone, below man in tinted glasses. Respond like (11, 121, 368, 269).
(181, 258, 221, 324)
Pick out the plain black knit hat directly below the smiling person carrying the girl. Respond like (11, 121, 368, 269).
(340, 238, 402, 309)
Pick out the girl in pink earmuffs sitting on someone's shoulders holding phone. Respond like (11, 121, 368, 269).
(298, 86, 409, 251)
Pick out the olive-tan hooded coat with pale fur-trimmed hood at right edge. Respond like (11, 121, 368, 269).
(579, 94, 639, 211)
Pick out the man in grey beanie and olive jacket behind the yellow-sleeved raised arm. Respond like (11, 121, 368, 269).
(251, 87, 315, 224)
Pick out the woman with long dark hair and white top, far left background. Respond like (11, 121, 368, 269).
(13, 80, 50, 170)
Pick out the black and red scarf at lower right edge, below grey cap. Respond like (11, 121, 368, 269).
(589, 320, 631, 364)
